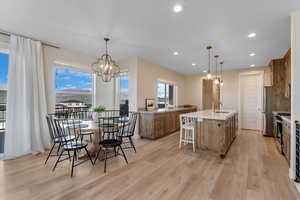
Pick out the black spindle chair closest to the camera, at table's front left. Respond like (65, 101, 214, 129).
(53, 119, 94, 177)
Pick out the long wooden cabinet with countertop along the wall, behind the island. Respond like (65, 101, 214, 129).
(139, 107, 197, 139)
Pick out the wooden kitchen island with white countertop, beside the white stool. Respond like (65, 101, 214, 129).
(181, 110, 238, 158)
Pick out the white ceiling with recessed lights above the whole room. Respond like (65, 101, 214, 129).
(0, 0, 300, 74)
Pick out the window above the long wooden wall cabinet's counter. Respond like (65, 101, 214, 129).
(157, 81, 176, 108)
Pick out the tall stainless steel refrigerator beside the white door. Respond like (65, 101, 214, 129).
(262, 86, 274, 137)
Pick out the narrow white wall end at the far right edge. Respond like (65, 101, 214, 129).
(290, 11, 300, 178)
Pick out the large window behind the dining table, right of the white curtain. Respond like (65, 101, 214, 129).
(55, 67, 93, 111)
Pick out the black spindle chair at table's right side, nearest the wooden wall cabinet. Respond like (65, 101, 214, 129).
(120, 112, 138, 153)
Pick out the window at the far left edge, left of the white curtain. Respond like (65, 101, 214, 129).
(0, 49, 9, 132)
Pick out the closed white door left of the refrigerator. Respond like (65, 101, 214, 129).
(240, 73, 263, 130)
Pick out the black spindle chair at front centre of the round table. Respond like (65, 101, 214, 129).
(94, 113, 128, 173)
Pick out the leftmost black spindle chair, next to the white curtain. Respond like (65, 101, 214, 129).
(45, 114, 76, 165)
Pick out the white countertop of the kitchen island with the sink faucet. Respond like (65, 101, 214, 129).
(180, 110, 237, 121)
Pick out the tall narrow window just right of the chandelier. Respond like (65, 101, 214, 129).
(119, 72, 129, 113)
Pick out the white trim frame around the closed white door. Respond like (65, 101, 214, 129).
(238, 70, 265, 133)
